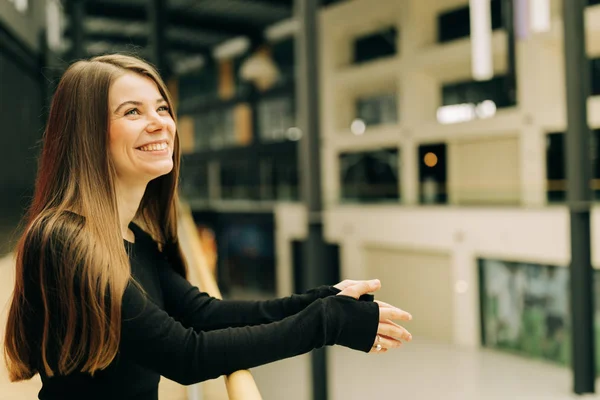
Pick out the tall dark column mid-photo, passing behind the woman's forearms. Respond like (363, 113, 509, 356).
(294, 0, 327, 400)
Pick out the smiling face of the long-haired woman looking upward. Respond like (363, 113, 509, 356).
(108, 72, 176, 185)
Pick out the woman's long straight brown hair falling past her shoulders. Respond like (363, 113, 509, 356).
(4, 55, 186, 381)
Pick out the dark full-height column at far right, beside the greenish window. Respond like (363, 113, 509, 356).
(563, 0, 596, 394)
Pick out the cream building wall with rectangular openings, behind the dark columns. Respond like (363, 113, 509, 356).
(286, 0, 600, 347)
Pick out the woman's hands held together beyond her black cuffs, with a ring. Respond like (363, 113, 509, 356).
(334, 279, 412, 353)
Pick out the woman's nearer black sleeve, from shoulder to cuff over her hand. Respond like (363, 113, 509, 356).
(121, 278, 379, 384)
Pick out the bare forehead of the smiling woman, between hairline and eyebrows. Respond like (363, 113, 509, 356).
(108, 72, 162, 106)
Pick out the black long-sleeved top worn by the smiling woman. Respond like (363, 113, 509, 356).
(30, 224, 379, 400)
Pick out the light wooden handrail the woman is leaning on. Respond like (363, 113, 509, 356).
(178, 201, 262, 400)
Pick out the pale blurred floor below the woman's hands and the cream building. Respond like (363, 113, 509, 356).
(253, 340, 600, 400)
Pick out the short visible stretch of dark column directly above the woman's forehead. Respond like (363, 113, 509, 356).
(147, 0, 170, 80)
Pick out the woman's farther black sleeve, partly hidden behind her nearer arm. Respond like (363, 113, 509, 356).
(158, 265, 340, 331)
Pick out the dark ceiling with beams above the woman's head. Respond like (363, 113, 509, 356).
(64, 0, 340, 73)
